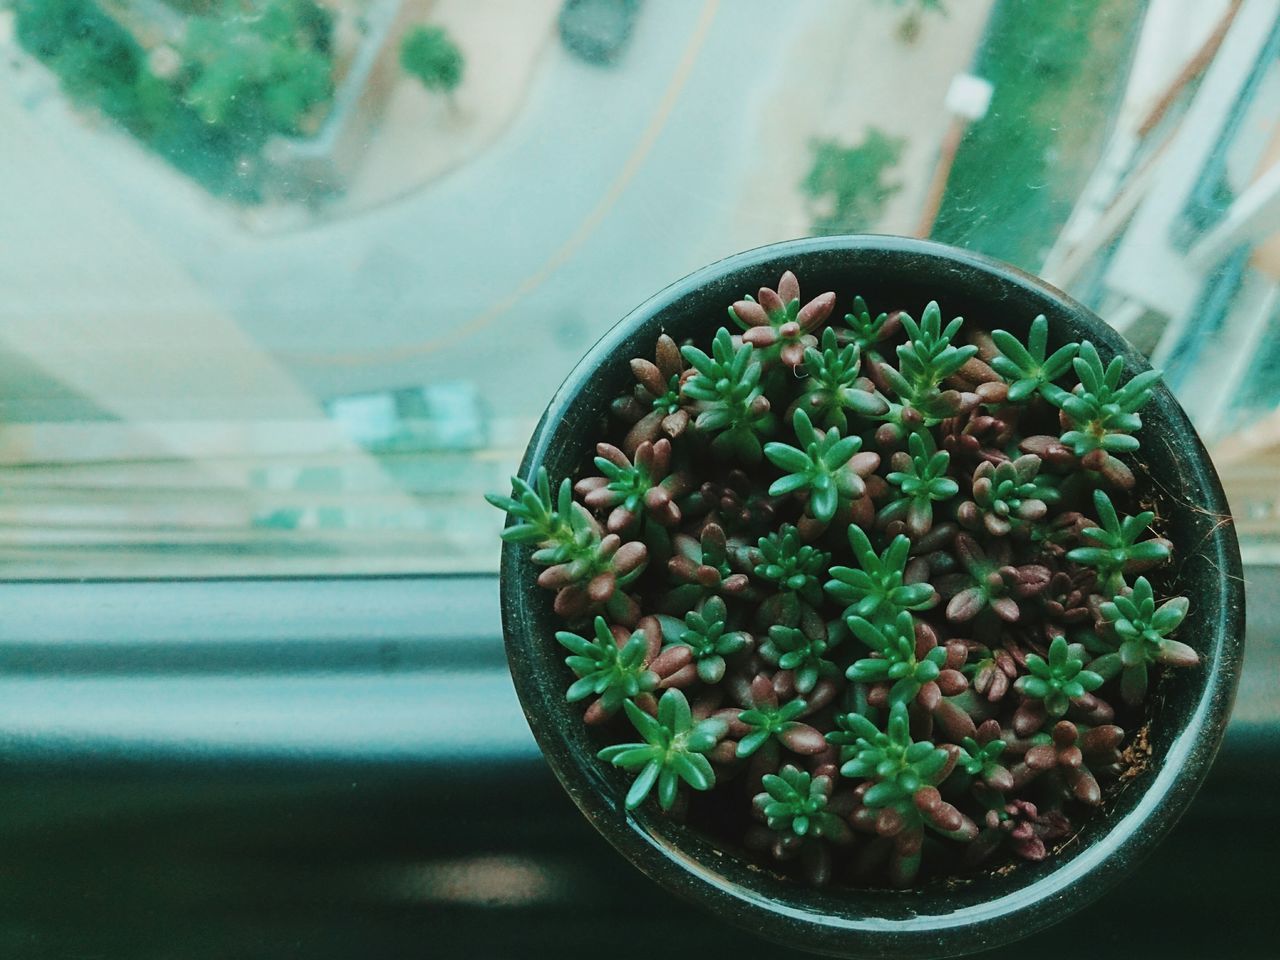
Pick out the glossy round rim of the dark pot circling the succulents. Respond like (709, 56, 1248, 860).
(502, 234, 1244, 956)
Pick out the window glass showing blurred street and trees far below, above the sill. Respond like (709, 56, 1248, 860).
(0, 0, 1280, 579)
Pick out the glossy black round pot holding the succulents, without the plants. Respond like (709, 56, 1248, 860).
(502, 237, 1244, 957)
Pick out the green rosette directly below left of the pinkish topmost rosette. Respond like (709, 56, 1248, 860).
(680, 326, 774, 463)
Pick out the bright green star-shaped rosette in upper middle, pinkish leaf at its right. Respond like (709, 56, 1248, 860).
(764, 410, 879, 524)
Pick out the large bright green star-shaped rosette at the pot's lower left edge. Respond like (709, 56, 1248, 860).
(599, 690, 727, 810)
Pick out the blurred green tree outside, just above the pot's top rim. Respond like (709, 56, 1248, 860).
(800, 128, 905, 234)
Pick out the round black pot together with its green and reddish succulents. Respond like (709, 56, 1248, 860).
(492, 237, 1244, 956)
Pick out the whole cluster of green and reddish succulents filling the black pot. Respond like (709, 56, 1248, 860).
(489, 273, 1197, 887)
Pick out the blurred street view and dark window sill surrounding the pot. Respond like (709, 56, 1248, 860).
(0, 0, 1280, 960)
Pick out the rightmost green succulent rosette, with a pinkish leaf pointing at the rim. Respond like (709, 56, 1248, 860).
(1085, 577, 1199, 707)
